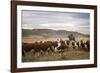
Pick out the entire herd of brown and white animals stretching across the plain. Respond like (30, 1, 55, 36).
(22, 40, 90, 56)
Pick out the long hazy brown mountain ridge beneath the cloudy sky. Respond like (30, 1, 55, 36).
(22, 29, 89, 37)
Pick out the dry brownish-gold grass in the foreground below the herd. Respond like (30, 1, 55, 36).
(22, 49, 89, 62)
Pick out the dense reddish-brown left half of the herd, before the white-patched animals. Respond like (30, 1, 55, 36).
(22, 41, 57, 55)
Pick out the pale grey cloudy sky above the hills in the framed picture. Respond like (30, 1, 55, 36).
(21, 10, 90, 34)
